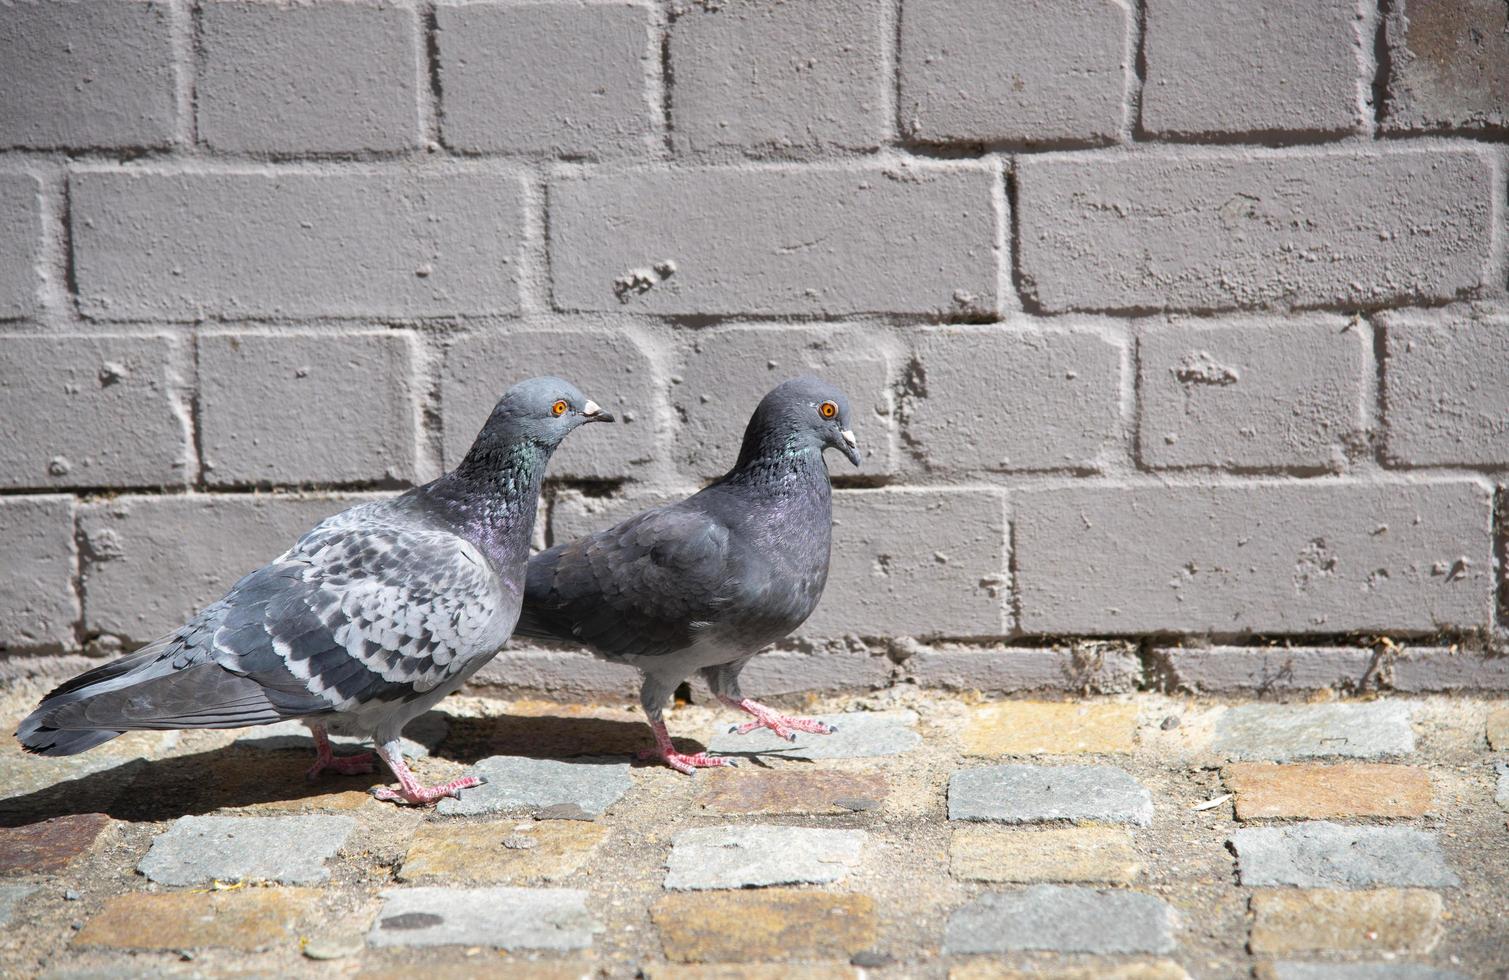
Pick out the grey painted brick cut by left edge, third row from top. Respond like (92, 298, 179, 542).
(0, 335, 196, 488)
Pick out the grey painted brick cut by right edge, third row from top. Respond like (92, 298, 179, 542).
(1381, 313, 1509, 467)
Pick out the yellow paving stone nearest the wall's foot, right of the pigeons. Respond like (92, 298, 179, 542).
(964, 701, 1136, 755)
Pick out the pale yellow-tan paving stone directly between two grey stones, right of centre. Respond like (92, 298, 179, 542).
(949, 827, 1142, 885)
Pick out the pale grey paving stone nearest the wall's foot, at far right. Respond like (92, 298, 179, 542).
(1212, 701, 1414, 763)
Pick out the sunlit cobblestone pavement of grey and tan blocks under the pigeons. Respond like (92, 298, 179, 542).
(0, 679, 1509, 980)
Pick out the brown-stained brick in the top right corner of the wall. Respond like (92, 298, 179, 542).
(1381, 0, 1509, 131)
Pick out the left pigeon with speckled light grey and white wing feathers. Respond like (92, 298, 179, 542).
(17, 378, 613, 803)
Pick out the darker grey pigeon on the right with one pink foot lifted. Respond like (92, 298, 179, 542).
(515, 378, 860, 775)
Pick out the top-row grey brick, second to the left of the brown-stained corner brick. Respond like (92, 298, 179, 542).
(901, 0, 1132, 143)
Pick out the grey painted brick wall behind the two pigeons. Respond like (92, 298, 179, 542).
(0, 0, 1509, 692)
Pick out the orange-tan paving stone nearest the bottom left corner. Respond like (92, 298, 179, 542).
(74, 888, 321, 953)
